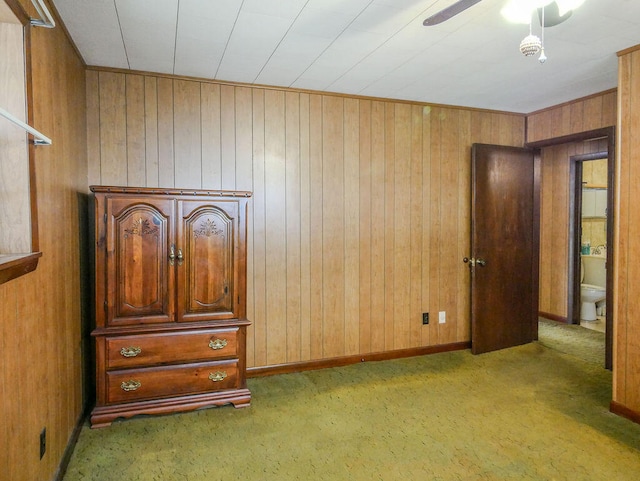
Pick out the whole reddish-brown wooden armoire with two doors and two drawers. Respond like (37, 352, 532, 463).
(91, 186, 251, 427)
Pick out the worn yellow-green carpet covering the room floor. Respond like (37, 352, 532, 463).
(64, 326, 640, 481)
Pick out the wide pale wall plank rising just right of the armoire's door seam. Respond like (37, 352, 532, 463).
(173, 80, 202, 189)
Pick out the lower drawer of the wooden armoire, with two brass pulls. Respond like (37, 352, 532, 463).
(106, 360, 240, 404)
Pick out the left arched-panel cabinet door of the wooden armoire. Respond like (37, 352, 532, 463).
(105, 196, 175, 326)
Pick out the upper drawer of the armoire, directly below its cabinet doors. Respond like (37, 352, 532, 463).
(105, 327, 239, 369)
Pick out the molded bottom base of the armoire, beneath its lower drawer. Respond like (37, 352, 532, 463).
(91, 389, 251, 428)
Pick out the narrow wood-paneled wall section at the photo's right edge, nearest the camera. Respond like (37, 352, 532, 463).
(613, 47, 640, 416)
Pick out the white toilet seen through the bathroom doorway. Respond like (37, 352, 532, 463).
(580, 255, 607, 321)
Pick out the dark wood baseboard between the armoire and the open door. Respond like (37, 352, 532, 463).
(247, 341, 471, 378)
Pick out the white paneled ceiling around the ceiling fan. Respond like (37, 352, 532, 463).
(52, 0, 640, 113)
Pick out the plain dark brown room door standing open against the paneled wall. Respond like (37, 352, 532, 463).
(471, 144, 539, 354)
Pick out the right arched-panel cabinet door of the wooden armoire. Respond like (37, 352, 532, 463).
(177, 200, 239, 321)
